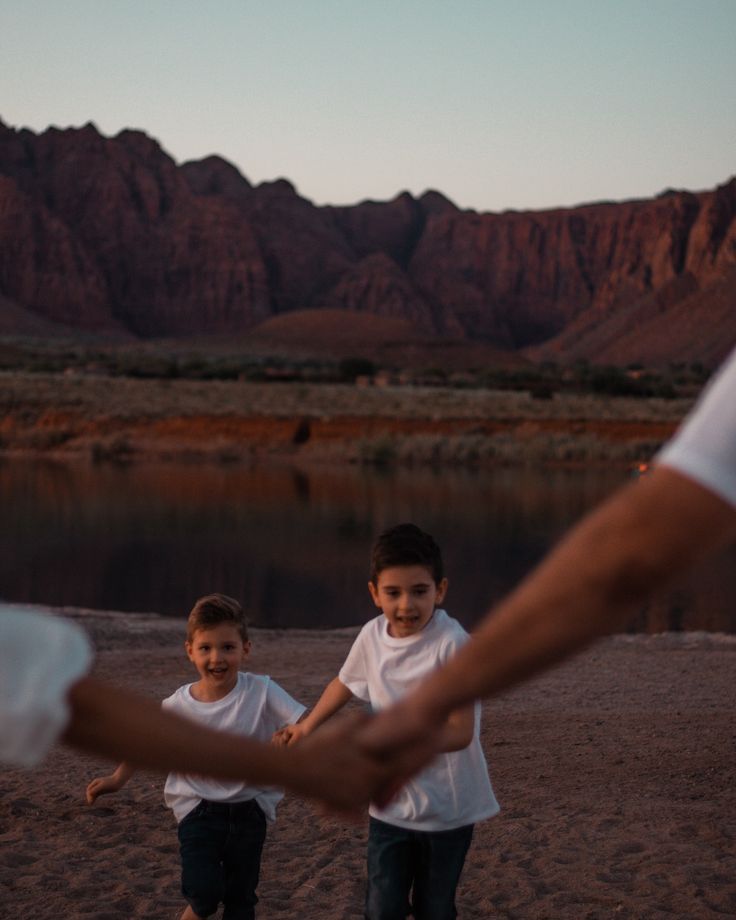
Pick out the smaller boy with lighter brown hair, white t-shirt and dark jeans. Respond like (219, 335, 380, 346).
(87, 594, 305, 920)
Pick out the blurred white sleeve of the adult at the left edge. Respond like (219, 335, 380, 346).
(0, 606, 92, 767)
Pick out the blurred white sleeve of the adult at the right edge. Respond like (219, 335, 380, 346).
(655, 351, 736, 505)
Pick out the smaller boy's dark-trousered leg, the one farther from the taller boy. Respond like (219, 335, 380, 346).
(178, 802, 227, 918)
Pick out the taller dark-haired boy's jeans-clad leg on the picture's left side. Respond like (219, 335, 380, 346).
(365, 818, 415, 920)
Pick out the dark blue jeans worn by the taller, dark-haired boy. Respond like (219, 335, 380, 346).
(365, 818, 473, 920)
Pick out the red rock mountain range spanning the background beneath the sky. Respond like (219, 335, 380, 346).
(0, 122, 736, 364)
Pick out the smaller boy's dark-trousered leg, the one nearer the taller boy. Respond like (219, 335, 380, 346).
(222, 799, 266, 920)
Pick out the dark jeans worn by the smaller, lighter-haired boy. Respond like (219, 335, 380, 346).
(179, 799, 266, 920)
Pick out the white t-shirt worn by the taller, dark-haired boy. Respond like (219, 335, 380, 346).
(339, 610, 499, 831)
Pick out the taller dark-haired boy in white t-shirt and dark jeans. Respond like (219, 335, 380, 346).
(278, 524, 499, 920)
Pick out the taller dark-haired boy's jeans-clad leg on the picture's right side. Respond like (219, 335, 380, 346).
(412, 824, 473, 920)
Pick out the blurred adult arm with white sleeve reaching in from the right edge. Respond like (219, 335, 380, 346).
(368, 352, 736, 752)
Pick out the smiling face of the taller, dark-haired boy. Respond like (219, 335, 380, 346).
(368, 565, 447, 639)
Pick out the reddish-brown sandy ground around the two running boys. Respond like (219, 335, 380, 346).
(0, 611, 736, 920)
